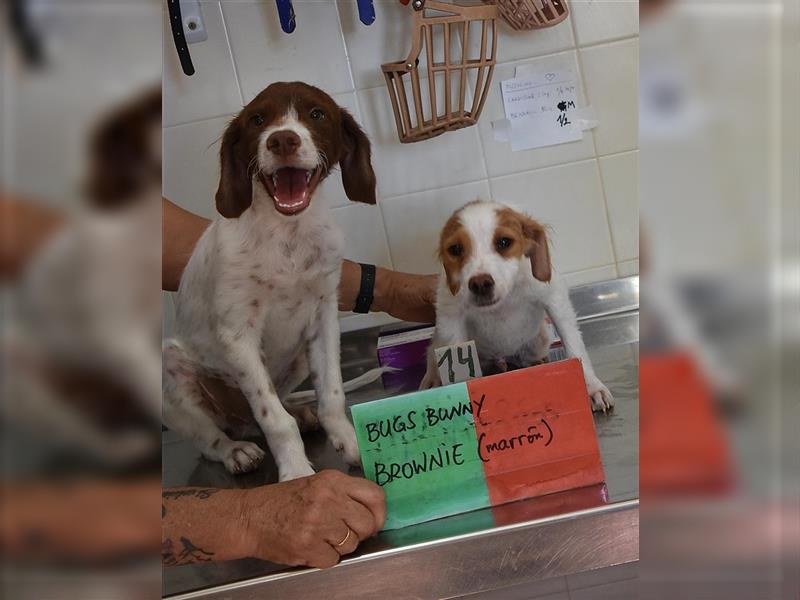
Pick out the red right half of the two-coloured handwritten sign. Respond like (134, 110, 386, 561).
(467, 359, 605, 505)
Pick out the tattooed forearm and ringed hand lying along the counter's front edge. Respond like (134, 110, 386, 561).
(161, 471, 386, 568)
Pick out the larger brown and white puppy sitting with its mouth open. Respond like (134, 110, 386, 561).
(163, 83, 375, 480)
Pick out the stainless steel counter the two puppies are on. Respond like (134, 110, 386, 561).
(163, 277, 639, 600)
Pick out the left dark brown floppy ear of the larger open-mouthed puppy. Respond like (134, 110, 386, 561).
(216, 117, 253, 219)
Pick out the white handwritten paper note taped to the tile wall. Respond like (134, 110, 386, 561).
(501, 67, 583, 151)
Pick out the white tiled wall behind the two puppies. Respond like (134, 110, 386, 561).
(164, 0, 638, 328)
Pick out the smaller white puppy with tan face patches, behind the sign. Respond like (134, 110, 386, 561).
(420, 200, 614, 411)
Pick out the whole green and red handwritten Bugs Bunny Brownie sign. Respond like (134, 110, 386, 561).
(352, 359, 604, 529)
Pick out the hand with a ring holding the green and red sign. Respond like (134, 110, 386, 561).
(238, 471, 386, 569)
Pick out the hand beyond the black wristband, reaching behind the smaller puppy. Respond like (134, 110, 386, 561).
(376, 269, 439, 323)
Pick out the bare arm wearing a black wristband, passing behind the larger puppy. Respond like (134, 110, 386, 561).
(162, 198, 437, 323)
